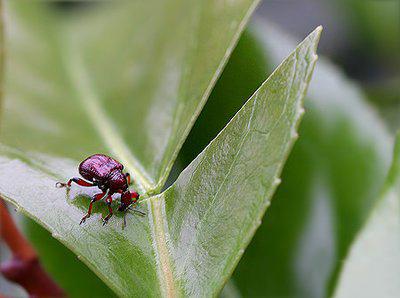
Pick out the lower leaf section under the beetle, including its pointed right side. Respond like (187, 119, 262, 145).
(0, 29, 321, 297)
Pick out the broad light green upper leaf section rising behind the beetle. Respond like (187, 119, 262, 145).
(1, 0, 257, 193)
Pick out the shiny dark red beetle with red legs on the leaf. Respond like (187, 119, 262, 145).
(56, 154, 145, 226)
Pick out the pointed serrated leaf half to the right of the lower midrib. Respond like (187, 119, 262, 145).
(149, 31, 319, 296)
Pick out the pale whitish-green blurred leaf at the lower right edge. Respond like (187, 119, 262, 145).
(335, 134, 400, 298)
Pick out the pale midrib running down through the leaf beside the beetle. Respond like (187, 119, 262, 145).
(59, 25, 183, 297)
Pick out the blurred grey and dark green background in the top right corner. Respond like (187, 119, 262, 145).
(256, 0, 400, 131)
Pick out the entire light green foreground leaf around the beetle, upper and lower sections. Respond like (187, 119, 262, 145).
(0, 1, 320, 297)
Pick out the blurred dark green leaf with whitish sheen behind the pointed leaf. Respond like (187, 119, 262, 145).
(186, 23, 391, 297)
